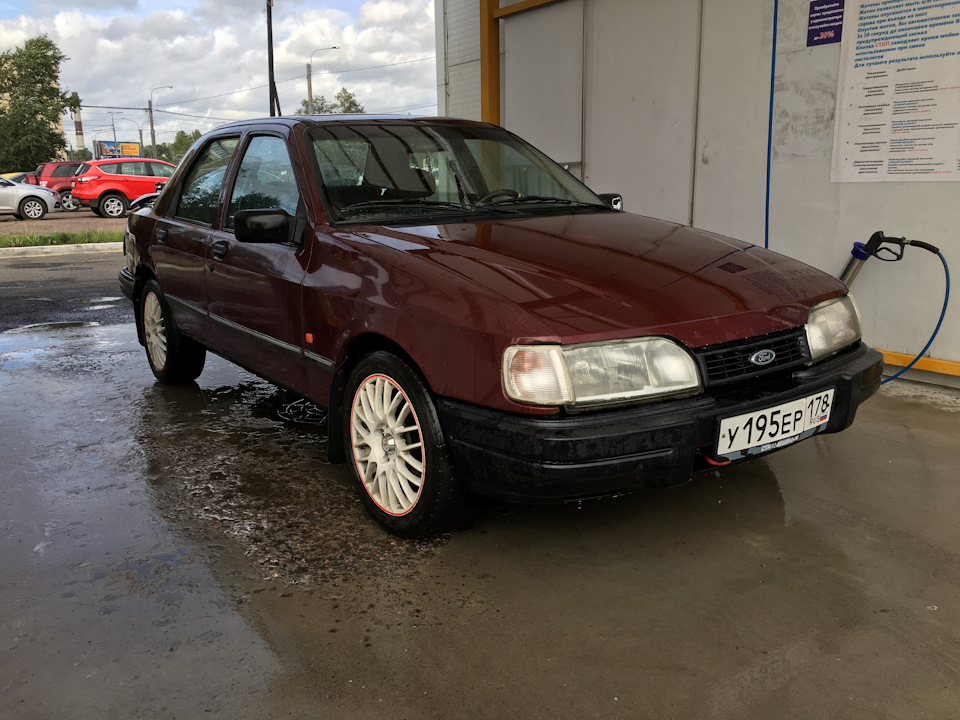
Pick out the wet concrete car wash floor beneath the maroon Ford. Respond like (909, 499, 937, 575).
(0, 324, 960, 720)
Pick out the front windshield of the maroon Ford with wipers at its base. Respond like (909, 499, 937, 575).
(311, 123, 610, 223)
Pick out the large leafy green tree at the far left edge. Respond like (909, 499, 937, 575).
(0, 35, 80, 171)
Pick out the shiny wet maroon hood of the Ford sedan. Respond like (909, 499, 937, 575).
(348, 213, 846, 347)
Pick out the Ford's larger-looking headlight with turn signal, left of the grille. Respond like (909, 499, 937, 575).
(503, 337, 700, 405)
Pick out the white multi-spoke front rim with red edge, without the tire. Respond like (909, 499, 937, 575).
(350, 373, 426, 516)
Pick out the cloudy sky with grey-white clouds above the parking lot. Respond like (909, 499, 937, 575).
(0, 0, 437, 152)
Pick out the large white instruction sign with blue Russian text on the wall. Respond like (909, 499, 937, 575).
(831, 0, 960, 182)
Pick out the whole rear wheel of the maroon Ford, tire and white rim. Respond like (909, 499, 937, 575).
(140, 280, 207, 385)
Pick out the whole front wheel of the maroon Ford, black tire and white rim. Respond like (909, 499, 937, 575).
(343, 351, 468, 538)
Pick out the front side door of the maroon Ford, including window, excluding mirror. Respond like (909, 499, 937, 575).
(206, 134, 308, 394)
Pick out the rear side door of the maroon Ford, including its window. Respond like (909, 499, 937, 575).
(149, 136, 240, 345)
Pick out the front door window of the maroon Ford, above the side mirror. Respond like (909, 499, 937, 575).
(223, 136, 300, 228)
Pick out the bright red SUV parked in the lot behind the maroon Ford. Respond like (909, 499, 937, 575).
(72, 158, 176, 218)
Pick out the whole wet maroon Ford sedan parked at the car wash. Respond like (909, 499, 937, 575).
(120, 116, 882, 536)
